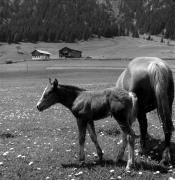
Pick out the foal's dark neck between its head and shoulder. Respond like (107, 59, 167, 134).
(58, 87, 81, 109)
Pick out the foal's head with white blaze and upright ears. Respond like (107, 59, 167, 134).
(37, 79, 58, 111)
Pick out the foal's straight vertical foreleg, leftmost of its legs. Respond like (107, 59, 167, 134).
(77, 119, 87, 164)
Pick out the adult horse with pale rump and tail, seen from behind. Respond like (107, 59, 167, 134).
(116, 57, 174, 164)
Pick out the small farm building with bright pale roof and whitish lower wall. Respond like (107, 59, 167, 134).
(32, 49, 51, 60)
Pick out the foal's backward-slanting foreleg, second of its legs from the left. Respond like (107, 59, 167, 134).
(87, 121, 103, 161)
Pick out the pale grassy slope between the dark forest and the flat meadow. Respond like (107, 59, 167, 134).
(0, 37, 175, 62)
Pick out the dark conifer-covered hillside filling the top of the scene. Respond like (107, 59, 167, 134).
(0, 0, 175, 44)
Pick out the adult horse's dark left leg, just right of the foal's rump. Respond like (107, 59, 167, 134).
(137, 111, 148, 153)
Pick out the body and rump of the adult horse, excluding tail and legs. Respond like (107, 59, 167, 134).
(116, 57, 174, 111)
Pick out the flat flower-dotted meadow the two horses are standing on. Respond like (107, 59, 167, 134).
(0, 60, 175, 180)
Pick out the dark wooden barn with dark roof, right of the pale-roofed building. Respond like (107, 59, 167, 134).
(59, 47, 82, 58)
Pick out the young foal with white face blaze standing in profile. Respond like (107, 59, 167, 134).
(37, 79, 137, 170)
